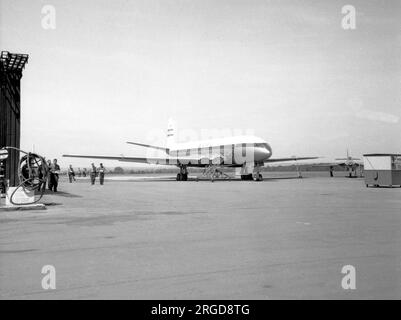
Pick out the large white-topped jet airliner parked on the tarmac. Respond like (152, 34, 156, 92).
(63, 120, 318, 181)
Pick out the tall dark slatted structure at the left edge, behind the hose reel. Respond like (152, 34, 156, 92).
(0, 51, 28, 186)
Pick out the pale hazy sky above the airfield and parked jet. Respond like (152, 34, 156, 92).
(0, 0, 401, 166)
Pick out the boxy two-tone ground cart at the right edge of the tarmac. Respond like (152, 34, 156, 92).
(363, 153, 401, 187)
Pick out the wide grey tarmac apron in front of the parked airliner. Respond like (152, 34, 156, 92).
(0, 173, 401, 299)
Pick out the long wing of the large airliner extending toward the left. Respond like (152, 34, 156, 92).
(63, 154, 219, 167)
